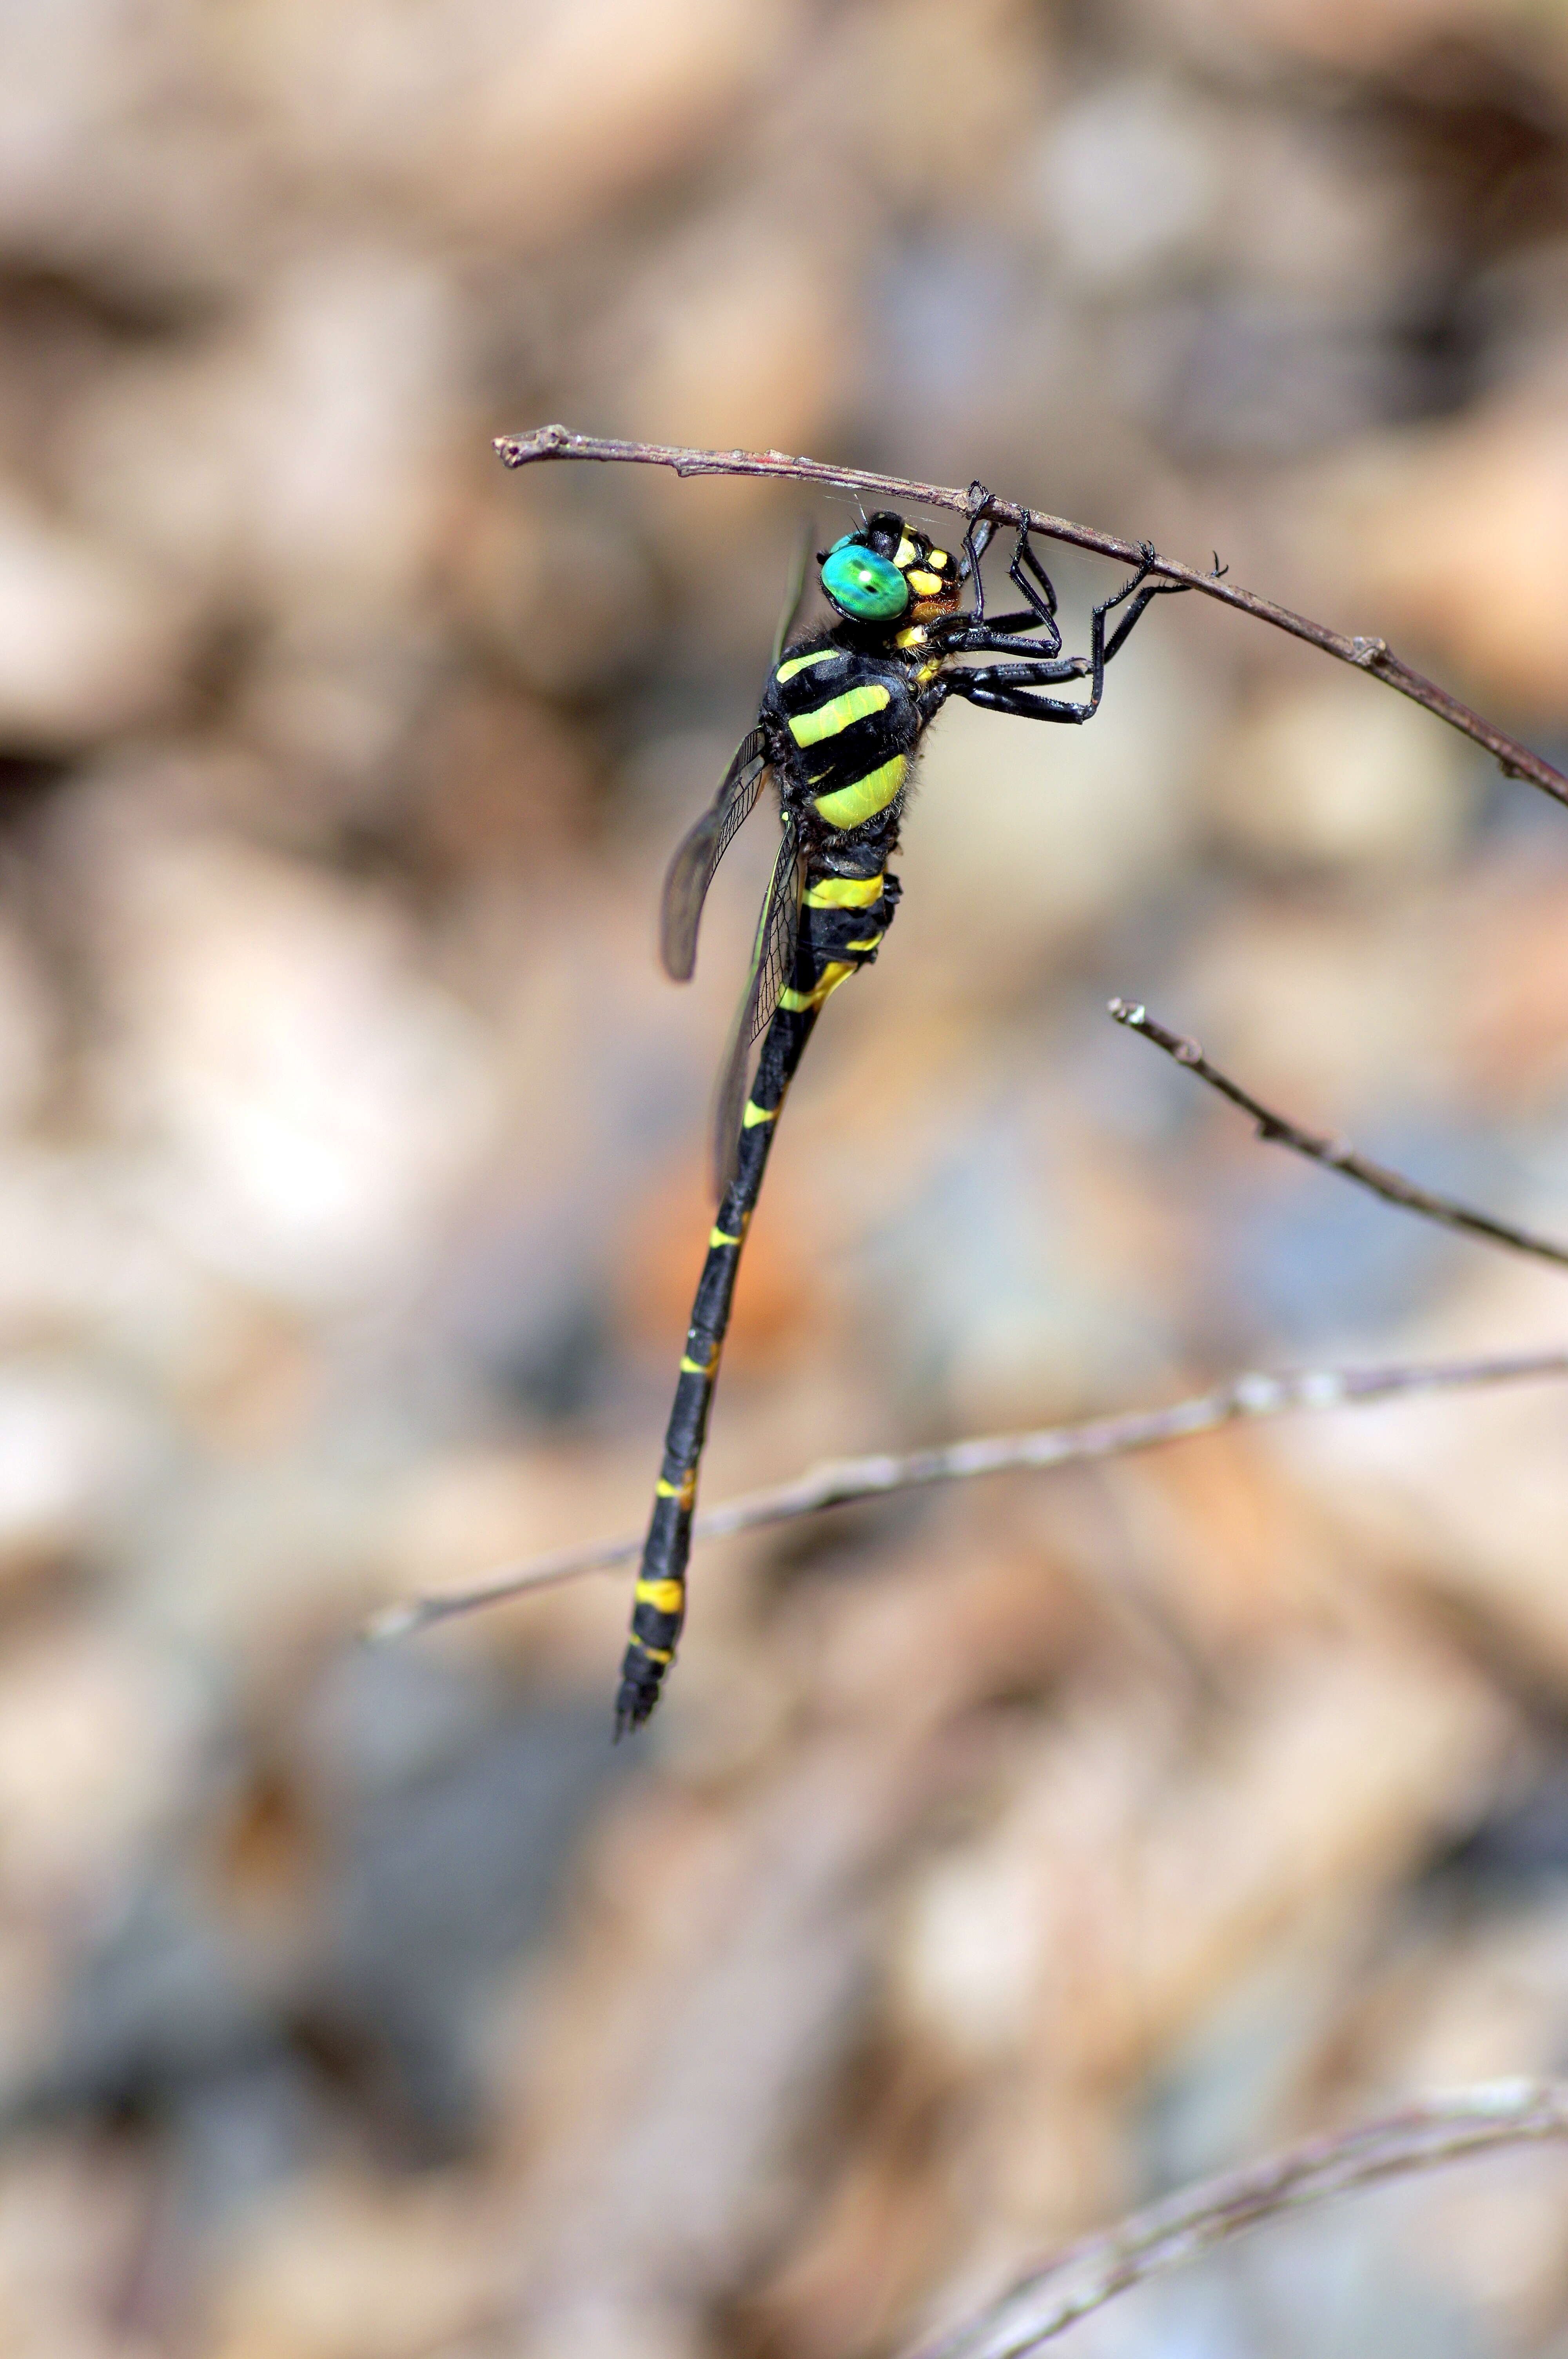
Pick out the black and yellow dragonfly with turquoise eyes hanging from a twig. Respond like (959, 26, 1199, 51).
(615, 483, 1179, 1734)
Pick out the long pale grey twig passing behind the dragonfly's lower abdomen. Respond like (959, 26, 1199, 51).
(368, 1352, 1568, 1639)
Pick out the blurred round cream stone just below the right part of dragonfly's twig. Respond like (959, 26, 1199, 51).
(1205, 677, 1474, 878)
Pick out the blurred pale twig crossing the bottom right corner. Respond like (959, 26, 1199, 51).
(910, 2081, 1568, 2359)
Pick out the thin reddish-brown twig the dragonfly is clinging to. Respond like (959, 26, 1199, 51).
(495, 427, 1568, 802)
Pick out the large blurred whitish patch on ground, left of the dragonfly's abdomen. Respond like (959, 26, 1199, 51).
(84, 835, 497, 1302)
